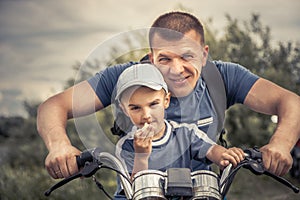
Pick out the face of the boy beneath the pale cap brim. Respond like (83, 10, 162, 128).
(121, 87, 170, 134)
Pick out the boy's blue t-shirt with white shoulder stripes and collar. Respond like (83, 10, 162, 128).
(116, 120, 216, 174)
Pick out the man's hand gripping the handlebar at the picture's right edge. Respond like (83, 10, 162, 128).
(260, 144, 293, 176)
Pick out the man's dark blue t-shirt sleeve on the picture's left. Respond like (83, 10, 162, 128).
(87, 62, 137, 107)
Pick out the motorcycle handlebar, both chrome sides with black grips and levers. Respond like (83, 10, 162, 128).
(45, 148, 299, 199)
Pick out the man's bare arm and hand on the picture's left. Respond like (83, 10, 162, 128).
(37, 81, 103, 178)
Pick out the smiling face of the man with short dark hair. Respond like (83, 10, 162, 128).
(150, 30, 208, 97)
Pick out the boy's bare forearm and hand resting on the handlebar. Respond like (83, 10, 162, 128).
(206, 144, 245, 168)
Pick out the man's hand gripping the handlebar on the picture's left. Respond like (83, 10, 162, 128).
(45, 145, 80, 179)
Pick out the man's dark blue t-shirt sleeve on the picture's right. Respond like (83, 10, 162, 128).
(214, 61, 259, 108)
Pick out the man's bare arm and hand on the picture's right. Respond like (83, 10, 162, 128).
(244, 78, 300, 176)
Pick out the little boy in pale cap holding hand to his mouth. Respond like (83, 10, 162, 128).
(116, 64, 244, 181)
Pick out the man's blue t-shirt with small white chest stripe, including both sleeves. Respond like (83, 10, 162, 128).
(88, 61, 259, 141)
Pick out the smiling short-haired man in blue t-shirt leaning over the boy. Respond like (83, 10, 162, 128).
(37, 12, 300, 178)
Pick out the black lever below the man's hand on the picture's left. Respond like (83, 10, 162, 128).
(44, 161, 101, 196)
